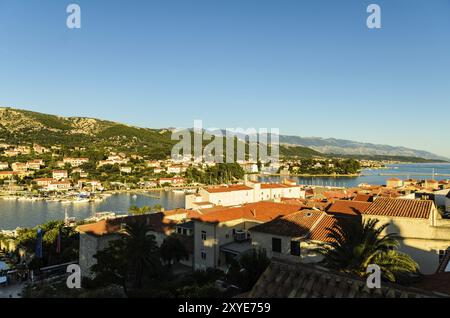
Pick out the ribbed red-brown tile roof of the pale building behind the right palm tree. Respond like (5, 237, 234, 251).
(362, 198, 434, 219)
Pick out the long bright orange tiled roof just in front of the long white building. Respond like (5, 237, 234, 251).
(193, 201, 301, 223)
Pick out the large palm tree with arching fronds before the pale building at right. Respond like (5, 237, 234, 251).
(317, 219, 419, 282)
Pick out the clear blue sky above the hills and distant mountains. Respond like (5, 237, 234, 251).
(0, 0, 450, 157)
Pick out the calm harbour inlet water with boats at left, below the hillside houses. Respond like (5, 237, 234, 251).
(0, 191, 184, 230)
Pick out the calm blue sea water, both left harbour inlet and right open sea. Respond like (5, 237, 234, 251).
(0, 164, 450, 229)
